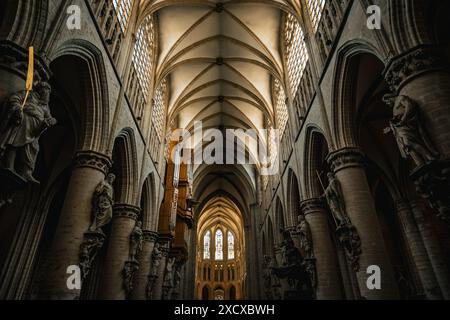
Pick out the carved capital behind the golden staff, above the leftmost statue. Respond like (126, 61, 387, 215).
(0, 40, 51, 82)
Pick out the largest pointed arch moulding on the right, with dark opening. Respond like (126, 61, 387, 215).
(330, 40, 383, 151)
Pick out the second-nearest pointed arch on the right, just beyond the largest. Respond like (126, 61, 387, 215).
(303, 126, 329, 199)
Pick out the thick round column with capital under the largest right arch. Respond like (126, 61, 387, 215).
(327, 148, 399, 299)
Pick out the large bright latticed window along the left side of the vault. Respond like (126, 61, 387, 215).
(133, 15, 155, 99)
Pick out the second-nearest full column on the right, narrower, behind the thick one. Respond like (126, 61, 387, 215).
(301, 199, 342, 300)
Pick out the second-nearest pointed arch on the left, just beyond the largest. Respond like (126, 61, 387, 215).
(112, 128, 139, 205)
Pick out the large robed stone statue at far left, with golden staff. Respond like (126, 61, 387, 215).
(0, 82, 57, 183)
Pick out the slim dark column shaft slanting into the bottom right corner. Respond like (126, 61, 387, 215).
(411, 202, 450, 300)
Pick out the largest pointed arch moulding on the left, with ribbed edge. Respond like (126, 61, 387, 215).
(50, 39, 110, 153)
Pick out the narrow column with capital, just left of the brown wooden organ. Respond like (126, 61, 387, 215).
(131, 230, 158, 300)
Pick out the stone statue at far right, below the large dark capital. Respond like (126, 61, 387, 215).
(384, 96, 439, 167)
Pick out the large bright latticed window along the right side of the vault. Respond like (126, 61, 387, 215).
(284, 14, 308, 97)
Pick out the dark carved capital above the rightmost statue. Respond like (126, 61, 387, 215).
(384, 46, 448, 93)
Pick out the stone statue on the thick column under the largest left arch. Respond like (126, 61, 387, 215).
(89, 173, 116, 233)
